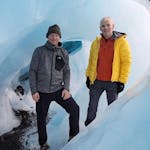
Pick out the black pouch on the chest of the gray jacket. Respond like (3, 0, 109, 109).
(55, 55, 65, 71)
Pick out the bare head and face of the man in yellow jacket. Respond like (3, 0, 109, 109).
(100, 19, 114, 39)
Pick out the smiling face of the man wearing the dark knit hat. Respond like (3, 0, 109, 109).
(48, 33, 60, 46)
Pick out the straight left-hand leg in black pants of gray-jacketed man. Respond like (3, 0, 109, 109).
(36, 93, 51, 146)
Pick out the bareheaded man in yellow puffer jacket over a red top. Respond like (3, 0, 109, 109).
(85, 17, 131, 126)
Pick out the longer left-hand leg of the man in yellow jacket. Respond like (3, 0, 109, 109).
(85, 80, 104, 126)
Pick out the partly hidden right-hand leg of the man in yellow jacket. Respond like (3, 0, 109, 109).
(106, 82, 118, 105)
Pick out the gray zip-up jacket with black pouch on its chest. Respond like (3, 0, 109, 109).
(29, 41, 70, 94)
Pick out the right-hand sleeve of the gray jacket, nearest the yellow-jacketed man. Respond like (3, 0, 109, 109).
(63, 53, 70, 91)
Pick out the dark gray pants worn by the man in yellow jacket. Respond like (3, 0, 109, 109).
(85, 80, 118, 126)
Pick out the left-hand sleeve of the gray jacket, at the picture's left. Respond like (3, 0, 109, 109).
(29, 49, 40, 94)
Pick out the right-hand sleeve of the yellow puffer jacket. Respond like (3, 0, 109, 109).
(119, 39, 132, 83)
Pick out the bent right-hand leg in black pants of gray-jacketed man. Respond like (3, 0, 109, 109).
(54, 90, 80, 137)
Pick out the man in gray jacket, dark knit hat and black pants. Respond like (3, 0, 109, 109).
(29, 24, 79, 150)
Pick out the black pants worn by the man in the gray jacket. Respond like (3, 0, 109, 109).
(36, 90, 79, 145)
